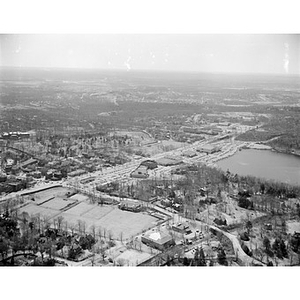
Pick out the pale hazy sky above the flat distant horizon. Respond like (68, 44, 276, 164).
(0, 34, 300, 74)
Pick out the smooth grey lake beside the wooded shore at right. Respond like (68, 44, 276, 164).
(217, 149, 300, 185)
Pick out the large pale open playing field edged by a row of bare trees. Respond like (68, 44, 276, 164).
(20, 188, 158, 239)
